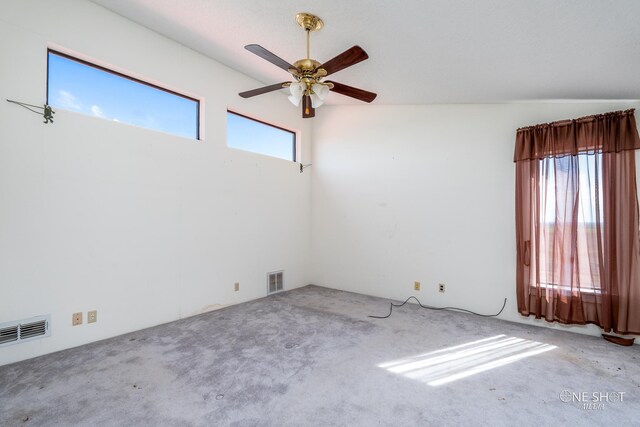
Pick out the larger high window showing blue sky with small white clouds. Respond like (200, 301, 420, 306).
(47, 51, 199, 139)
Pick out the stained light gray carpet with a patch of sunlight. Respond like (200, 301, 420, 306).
(0, 286, 640, 426)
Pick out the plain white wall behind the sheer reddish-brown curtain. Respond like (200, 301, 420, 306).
(311, 102, 640, 342)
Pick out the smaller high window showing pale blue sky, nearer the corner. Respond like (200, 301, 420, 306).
(227, 111, 296, 161)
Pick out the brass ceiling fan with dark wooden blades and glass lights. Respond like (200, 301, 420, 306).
(239, 13, 377, 119)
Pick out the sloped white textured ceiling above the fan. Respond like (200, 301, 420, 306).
(92, 0, 640, 104)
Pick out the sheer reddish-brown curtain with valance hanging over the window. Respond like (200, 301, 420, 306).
(514, 110, 640, 334)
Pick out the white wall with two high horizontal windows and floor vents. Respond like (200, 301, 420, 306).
(0, 0, 310, 364)
